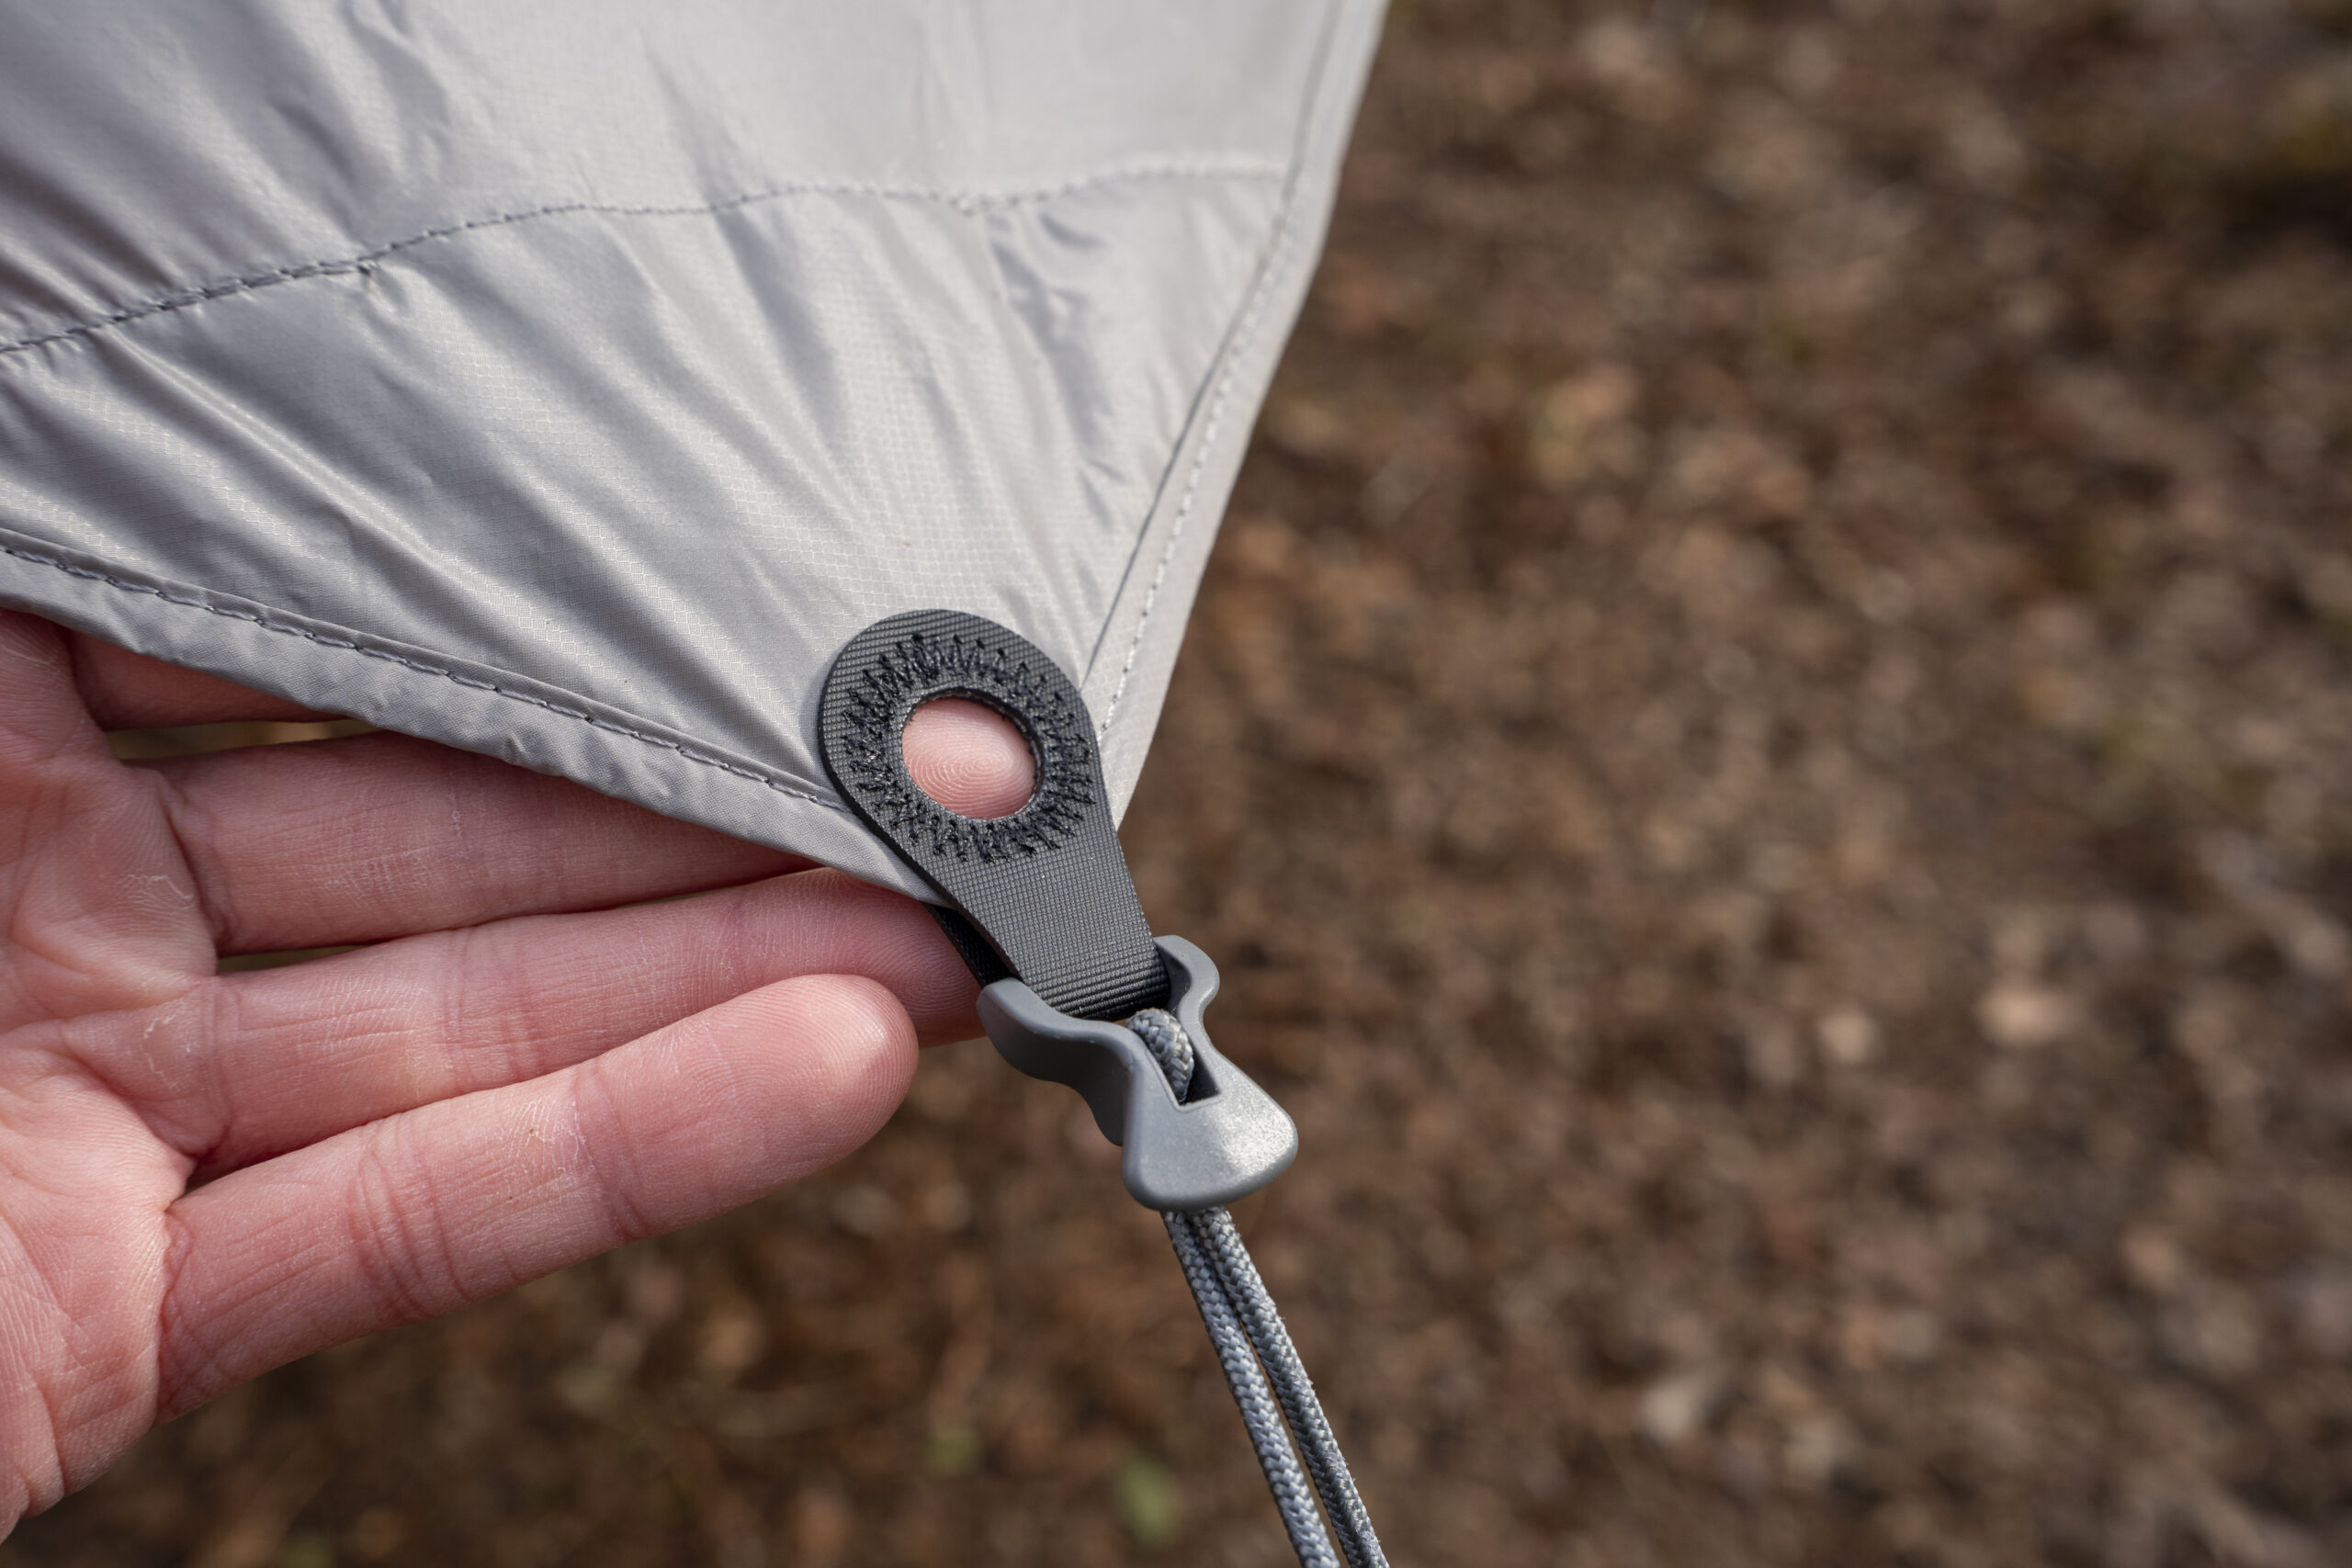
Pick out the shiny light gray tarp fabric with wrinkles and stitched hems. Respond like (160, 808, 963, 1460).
(0, 0, 1378, 891)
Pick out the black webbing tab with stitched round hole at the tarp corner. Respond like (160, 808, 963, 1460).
(819, 609, 1169, 1018)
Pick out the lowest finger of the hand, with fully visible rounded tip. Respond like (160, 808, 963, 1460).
(160, 976, 915, 1416)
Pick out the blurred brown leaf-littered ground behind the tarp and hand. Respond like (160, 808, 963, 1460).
(0, 0, 2352, 1568)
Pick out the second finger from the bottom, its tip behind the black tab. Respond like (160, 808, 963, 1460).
(68, 870, 978, 1176)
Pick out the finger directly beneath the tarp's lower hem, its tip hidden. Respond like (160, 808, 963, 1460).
(141, 733, 807, 954)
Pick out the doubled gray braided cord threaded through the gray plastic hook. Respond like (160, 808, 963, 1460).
(1126, 1009, 1387, 1568)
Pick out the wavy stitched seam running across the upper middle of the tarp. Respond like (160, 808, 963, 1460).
(0, 160, 1286, 355)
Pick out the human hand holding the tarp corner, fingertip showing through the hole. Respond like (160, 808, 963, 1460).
(0, 611, 1030, 1535)
